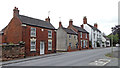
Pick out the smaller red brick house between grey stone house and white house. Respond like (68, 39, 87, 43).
(68, 20, 89, 49)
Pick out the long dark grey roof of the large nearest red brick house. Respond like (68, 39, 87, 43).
(18, 15, 55, 29)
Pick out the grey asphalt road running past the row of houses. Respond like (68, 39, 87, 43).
(3, 48, 118, 66)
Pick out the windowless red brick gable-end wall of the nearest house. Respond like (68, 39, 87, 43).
(2, 17, 22, 44)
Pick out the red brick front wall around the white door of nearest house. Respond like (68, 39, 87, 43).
(22, 25, 56, 56)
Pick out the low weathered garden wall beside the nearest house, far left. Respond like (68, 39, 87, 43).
(0, 44, 25, 61)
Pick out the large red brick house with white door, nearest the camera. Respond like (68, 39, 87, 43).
(2, 7, 56, 56)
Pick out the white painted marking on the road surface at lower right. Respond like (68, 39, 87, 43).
(89, 59, 110, 66)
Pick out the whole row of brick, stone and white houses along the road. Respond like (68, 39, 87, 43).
(0, 7, 110, 56)
